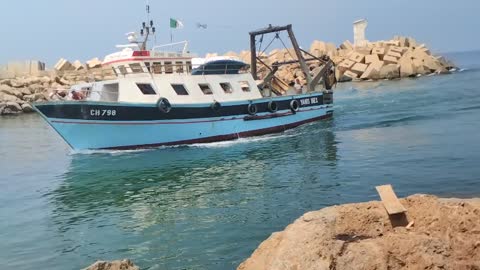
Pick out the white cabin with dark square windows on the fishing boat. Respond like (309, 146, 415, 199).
(77, 42, 262, 104)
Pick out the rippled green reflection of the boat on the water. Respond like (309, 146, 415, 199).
(48, 121, 337, 269)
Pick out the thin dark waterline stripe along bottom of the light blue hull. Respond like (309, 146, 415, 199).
(103, 111, 333, 150)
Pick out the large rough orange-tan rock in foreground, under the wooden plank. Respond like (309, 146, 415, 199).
(238, 195, 480, 270)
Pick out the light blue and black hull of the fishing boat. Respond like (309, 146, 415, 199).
(35, 95, 333, 150)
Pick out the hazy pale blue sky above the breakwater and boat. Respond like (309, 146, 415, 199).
(0, 0, 480, 66)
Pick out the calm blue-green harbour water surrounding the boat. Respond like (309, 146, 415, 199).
(0, 50, 480, 269)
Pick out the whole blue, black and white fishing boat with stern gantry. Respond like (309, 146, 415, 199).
(34, 11, 334, 150)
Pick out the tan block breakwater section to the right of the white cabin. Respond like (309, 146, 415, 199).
(216, 37, 456, 84)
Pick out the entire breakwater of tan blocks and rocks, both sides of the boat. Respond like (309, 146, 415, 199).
(0, 37, 456, 115)
